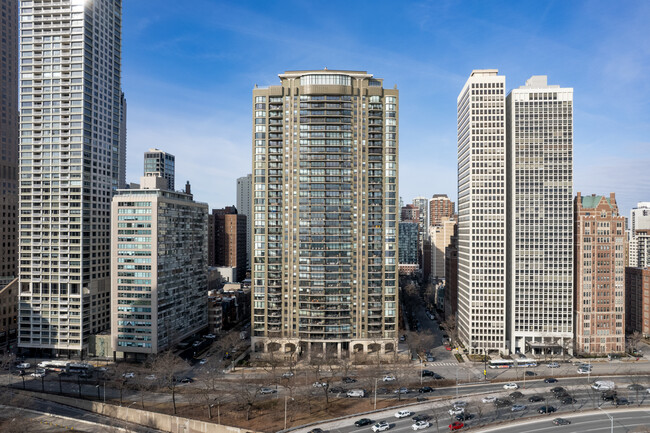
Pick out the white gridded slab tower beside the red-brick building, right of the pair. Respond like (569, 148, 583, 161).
(507, 76, 573, 354)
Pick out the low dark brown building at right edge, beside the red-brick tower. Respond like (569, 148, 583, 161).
(625, 267, 650, 338)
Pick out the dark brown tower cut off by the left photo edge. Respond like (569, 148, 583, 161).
(0, 0, 19, 290)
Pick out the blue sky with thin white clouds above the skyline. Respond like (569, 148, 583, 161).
(122, 0, 650, 216)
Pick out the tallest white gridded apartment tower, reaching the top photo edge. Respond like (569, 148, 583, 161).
(18, 0, 125, 354)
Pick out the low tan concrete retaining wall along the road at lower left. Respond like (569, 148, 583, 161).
(16, 391, 258, 433)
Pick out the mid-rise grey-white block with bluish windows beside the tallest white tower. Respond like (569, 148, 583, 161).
(111, 176, 208, 359)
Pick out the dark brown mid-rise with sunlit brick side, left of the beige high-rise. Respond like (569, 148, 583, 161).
(210, 206, 247, 281)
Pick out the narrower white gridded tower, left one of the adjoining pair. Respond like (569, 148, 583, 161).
(457, 69, 508, 353)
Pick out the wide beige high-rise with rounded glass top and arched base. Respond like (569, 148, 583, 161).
(251, 70, 399, 356)
